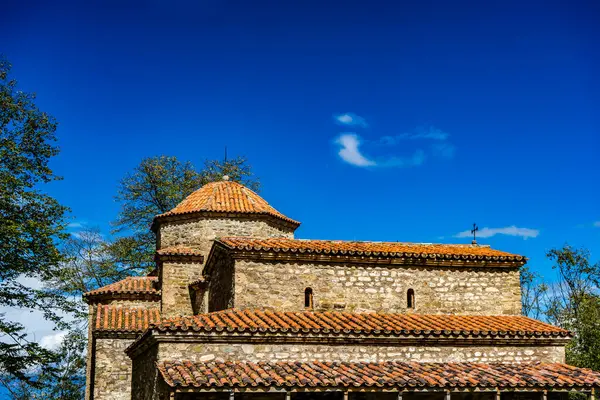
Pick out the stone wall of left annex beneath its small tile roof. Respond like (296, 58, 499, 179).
(93, 338, 133, 400)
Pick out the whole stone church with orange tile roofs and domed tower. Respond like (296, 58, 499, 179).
(84, 179, 600, 400)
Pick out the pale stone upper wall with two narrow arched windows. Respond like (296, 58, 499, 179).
(234, 260, 521, 315)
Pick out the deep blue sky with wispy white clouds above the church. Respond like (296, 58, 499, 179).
(0, 0, 600, 288)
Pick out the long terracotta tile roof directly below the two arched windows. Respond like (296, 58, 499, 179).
(155, 309, 570, 337)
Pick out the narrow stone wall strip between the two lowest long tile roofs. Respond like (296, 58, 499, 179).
(159, 342, 565, 363)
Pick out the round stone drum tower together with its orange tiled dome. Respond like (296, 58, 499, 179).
(152, 181, 300, 318)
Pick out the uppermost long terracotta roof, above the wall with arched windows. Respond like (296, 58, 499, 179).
(217, 237, 526, 261)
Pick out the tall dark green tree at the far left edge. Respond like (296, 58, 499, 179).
(0, 60, 81, 387)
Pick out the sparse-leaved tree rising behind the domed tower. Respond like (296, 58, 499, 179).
(107, 156, 260, 272)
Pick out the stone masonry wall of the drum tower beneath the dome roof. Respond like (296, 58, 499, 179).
(157, 216, 294, 318)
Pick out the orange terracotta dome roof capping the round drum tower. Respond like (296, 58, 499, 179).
(157, 181, 300, 226)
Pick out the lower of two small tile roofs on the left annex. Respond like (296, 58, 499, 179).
(94, 306, 160, 332)
